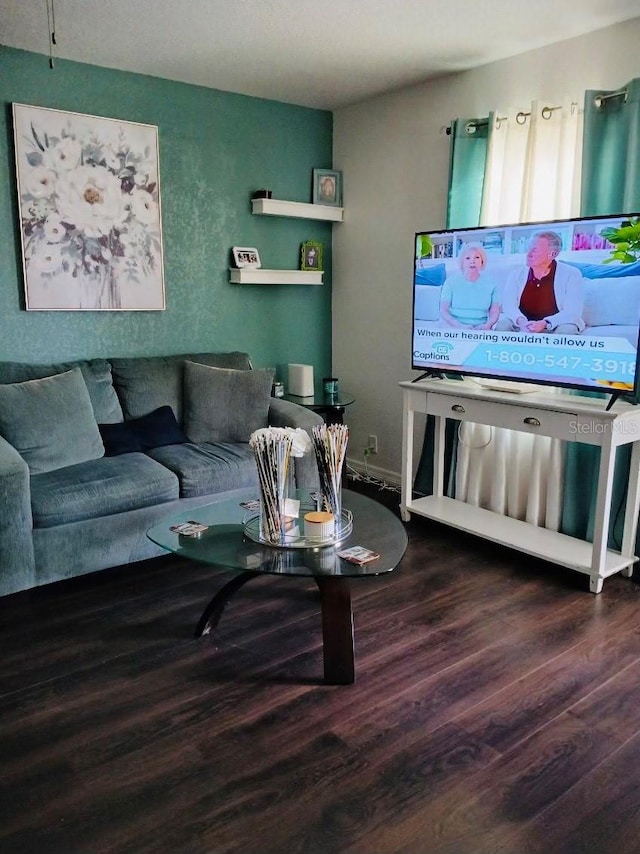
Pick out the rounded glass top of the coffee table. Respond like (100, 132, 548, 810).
(147, 489, 407, 577)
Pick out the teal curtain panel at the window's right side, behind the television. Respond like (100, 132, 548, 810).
(561, 78, 640, 548)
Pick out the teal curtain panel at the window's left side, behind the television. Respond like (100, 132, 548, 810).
(414, 116, 492, 495)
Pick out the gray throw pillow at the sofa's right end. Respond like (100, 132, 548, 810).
(183, 362, 272, 443)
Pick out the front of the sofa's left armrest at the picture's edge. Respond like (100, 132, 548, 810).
(0, 437, 36, 596)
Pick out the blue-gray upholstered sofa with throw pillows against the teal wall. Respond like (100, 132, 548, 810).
(0, 352, 322, 595)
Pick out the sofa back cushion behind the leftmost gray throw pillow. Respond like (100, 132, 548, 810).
(0, 359, 122, 424)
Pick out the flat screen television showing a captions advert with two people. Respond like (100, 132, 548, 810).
(411, 214, 640, 403)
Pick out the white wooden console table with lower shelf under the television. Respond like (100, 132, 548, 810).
(400, 379, 640, 593)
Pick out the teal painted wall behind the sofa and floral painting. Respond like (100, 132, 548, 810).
(0, 46, 333, 376)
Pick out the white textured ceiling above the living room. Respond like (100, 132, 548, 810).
(0, 0, 640, 109)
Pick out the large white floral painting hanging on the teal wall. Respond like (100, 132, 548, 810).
(13, 104, 165, 310)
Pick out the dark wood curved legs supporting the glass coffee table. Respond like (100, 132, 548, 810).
(195, 572, 356, 685)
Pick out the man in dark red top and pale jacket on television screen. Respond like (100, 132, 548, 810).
(495, 231, 585, 335)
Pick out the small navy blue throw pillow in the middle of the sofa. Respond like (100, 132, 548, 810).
(98, 406, 189, 457)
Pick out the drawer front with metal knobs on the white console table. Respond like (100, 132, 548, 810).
(427, 394, 581, 442)
